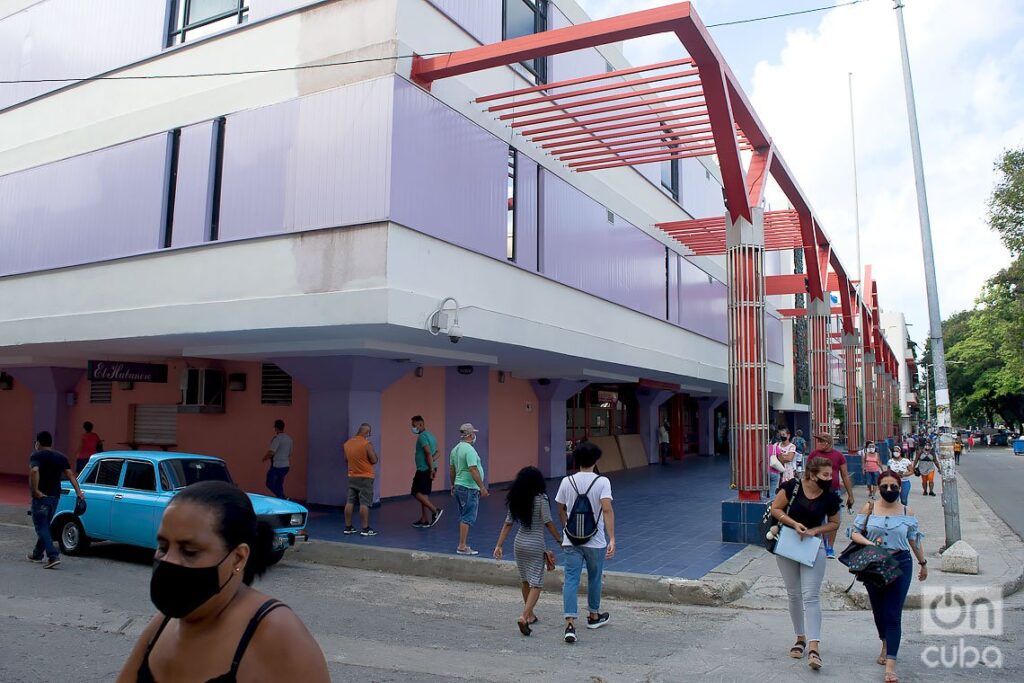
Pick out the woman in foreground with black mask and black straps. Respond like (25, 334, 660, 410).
(118, 481, 331, 683)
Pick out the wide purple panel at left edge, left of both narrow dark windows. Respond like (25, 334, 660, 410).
(0, 133, 168, 275)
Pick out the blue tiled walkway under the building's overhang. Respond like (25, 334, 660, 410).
(309, 457, 743, 579)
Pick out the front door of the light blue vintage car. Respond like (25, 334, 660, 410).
(111, 460, 165, 548)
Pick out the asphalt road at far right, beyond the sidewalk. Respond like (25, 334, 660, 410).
(958, 446, 1024, 539)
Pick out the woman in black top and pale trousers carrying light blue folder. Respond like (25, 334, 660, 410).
(771, 458, 842, 670)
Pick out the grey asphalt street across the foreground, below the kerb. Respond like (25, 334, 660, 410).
(0, 525, 1024, 683)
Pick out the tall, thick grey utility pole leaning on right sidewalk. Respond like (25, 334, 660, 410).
(893, 0, 958, 564)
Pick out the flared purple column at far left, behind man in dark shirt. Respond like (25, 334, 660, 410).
(7, 368, 85, 456)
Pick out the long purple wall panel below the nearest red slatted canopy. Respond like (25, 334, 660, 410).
(542, 172, 666, 319)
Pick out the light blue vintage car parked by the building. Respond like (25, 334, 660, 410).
(51, 451, 309, 562)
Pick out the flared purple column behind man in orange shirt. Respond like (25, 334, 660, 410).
(272, 355, 414, 506)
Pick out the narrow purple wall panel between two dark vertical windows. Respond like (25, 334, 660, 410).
(171, 121, 215, 247)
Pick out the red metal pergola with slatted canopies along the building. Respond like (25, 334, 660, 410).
(411, 2, 905, 500)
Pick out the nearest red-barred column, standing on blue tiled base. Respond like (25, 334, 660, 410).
(726, 208, 768, 501)
